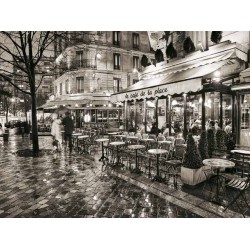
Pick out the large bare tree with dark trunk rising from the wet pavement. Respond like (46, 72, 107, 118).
(0, 31, 56, 156)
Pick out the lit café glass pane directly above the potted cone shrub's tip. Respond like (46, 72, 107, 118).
(187, 95, 202, 135)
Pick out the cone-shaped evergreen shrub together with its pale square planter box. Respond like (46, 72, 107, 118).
(181, 133, 209, 186)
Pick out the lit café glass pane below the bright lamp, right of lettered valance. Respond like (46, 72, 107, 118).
(205, 92, 220, 128)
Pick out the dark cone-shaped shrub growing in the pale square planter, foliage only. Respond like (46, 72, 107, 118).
(183, 133, 202, 169)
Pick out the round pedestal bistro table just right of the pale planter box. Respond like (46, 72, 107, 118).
(203, 158, 235, 204)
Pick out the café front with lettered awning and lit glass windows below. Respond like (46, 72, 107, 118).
(111, 41, 247, 141)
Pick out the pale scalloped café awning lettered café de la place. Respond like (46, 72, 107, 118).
(111, 43, 248, 103)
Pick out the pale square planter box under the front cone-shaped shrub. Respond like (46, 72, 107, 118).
(181, 166, 212, 186)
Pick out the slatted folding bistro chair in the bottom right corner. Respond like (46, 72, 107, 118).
(223, 168, 250, 217)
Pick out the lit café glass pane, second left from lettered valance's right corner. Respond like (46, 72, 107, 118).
(171, 96, 184, 134)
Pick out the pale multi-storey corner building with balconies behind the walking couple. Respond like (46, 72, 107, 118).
(45, 31, 154, 126)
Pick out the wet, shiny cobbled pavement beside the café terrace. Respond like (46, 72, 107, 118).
(0, 135, 201, 218)
